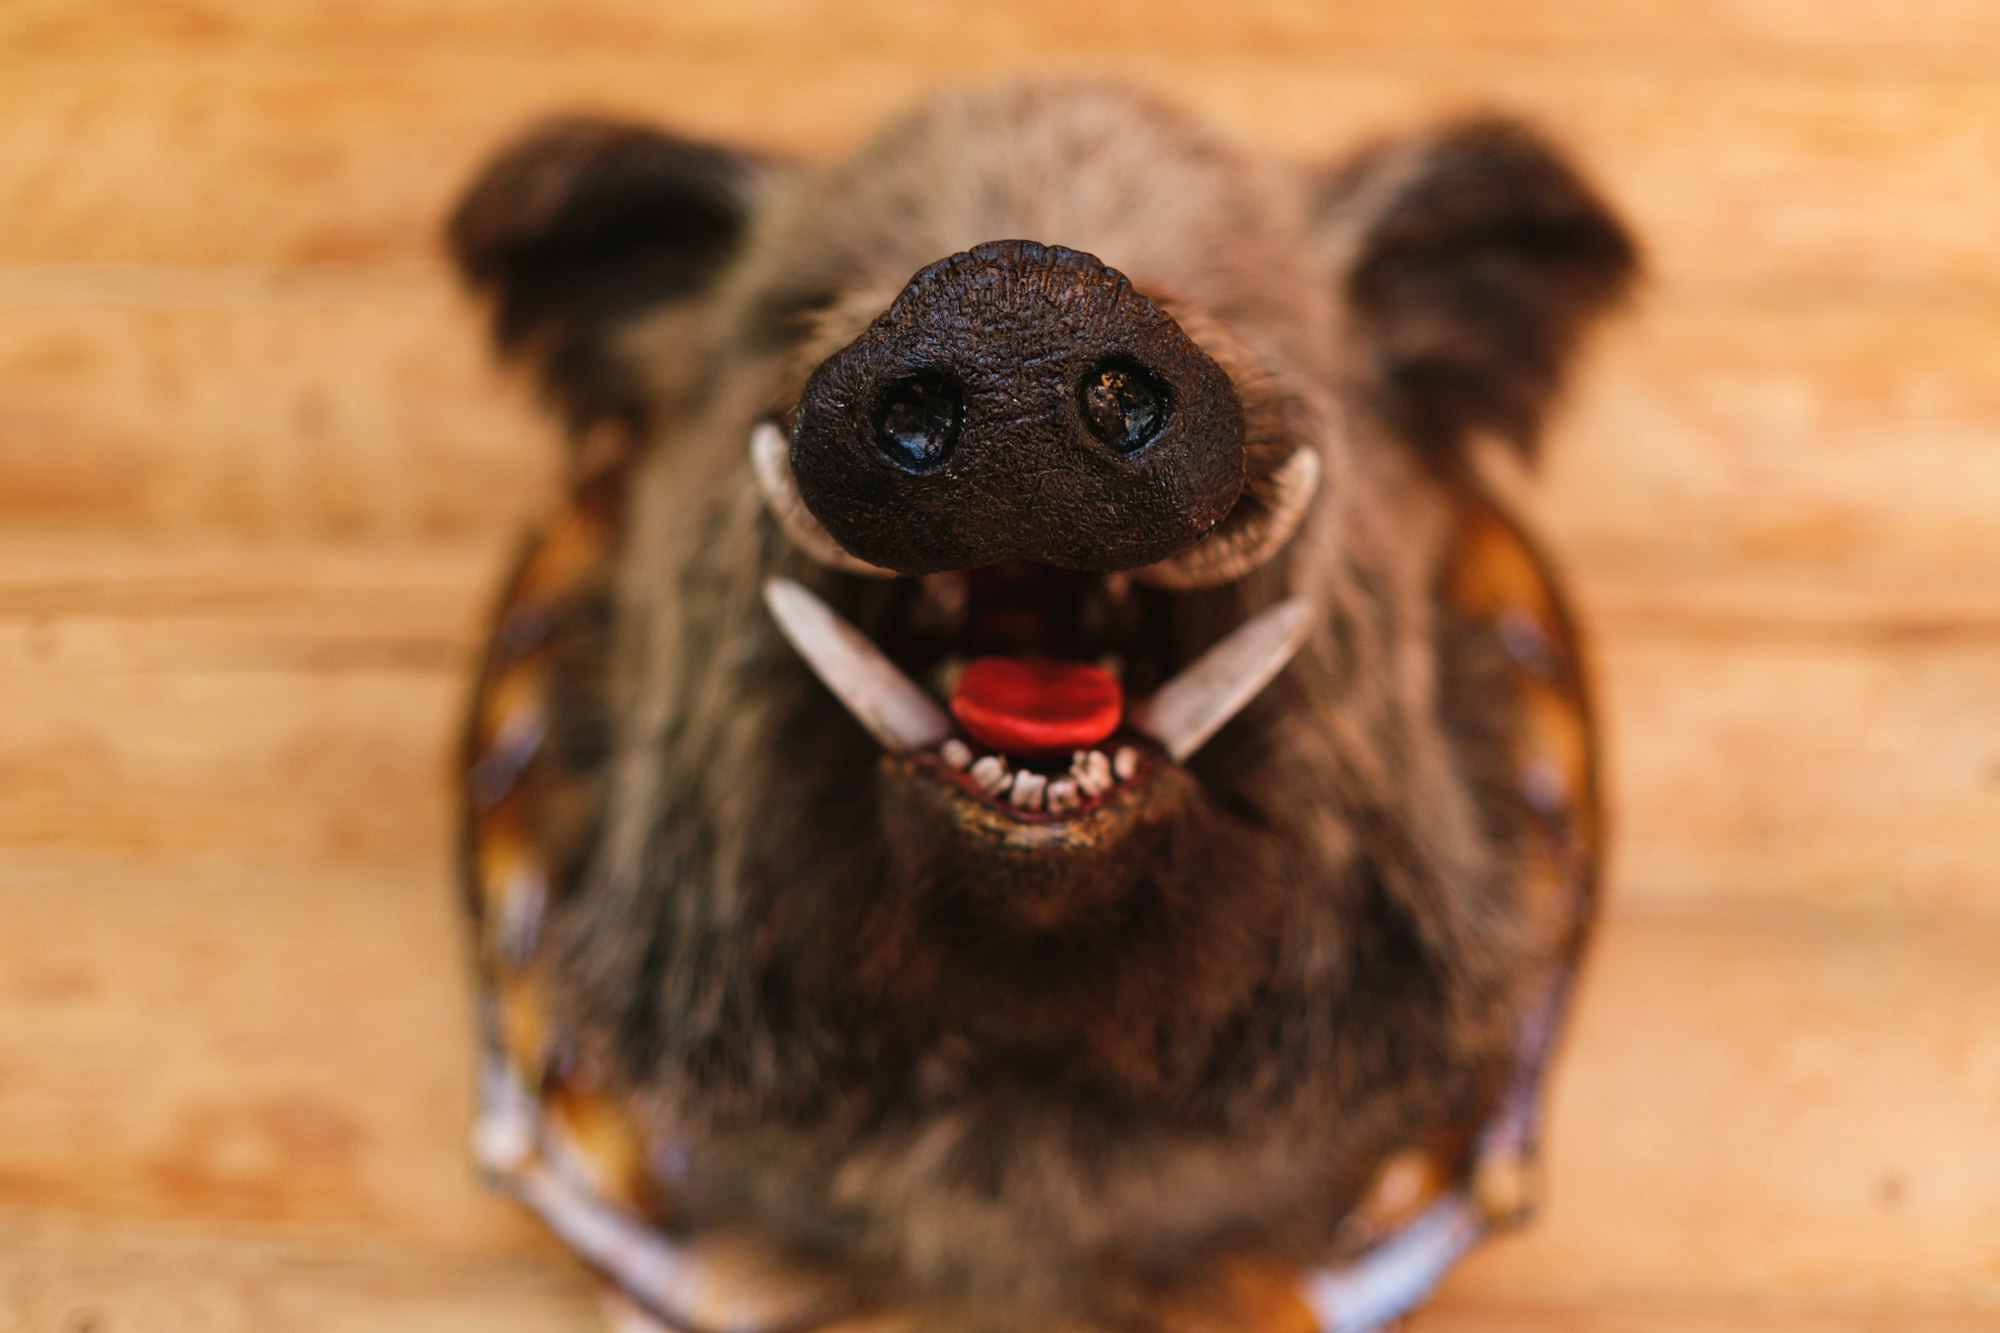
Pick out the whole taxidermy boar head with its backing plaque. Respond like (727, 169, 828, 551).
(450, 84, 1636, 1333)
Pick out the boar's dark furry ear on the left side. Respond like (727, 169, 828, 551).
(446, 116, 766, 428)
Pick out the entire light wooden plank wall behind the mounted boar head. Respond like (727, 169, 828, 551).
(0, 0, 2000, 1333)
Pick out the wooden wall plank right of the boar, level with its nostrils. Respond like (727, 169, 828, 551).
(1534, 292, 2000, 592)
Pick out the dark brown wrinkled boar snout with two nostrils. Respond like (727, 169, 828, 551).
(792, 240, 1244, 574)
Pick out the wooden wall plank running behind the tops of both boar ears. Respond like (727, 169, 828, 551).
(0, 53, 2000, 294)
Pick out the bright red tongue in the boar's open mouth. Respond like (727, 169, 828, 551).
(952, 656, 1124, 755)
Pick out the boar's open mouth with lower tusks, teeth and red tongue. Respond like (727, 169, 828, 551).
(764, 426, 1312, 823)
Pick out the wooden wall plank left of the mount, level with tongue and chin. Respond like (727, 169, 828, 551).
(0, 624, 464, 869)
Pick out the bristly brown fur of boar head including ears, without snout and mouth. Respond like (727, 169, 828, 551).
(454, 86, 1634, 1327)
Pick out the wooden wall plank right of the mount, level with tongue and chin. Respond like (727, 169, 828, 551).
(1600, 628, 2000, 911)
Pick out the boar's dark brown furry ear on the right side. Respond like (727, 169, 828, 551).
(1318, 118, 1638, 458)
